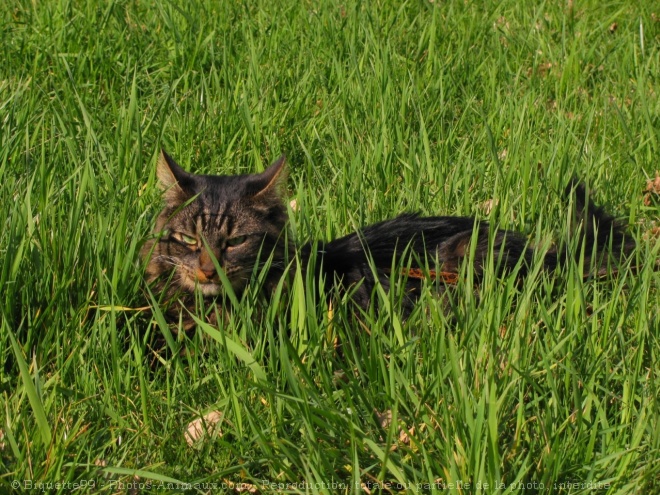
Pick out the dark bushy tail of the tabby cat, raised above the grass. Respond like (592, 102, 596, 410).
(545, 178, 635, 276)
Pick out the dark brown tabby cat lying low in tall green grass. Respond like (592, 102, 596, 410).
(141, 151, 635, 330)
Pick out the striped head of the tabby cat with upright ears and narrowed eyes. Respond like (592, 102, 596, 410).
(142, 151, 287, 296)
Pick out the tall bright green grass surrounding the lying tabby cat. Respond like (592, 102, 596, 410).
(0, 0, 660, 494)
